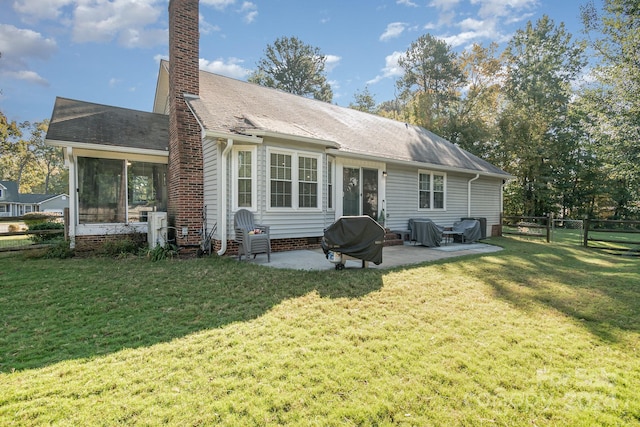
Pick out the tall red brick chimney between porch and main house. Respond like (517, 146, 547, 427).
(167, 0, 204, 251)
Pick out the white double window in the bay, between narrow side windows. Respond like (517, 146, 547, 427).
(269, 150, 322, 209)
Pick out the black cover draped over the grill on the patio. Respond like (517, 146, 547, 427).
(322, 215, 385, 265)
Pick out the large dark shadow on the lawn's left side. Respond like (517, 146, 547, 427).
(0, 257, 384, 372)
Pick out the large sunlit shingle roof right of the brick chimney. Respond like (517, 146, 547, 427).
(188, 71, 509, 177)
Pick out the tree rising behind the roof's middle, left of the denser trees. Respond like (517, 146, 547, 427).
(396, 34, 465, 133)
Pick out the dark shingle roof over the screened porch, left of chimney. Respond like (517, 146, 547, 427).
(47, 97, 169, 151)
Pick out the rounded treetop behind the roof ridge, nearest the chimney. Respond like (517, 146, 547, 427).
(248, 37, 333, 102)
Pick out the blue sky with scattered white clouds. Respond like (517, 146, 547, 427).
(0, 0, 602, 121)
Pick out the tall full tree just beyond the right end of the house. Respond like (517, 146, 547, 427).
(499, 15, 585, 216)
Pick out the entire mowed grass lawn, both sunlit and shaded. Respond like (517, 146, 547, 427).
(0, 238, 640, 426)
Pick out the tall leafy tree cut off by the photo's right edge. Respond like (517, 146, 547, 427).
(581, 0, 640, 218)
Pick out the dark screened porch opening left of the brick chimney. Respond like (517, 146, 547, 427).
(78, 157, 167, 224)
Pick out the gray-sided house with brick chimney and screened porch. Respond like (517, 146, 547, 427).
(46, 0, 512, 254)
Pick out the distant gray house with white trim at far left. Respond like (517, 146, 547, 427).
(0, 181, 69, 217)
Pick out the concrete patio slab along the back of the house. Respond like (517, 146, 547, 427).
(238, 243, 502, 270)
